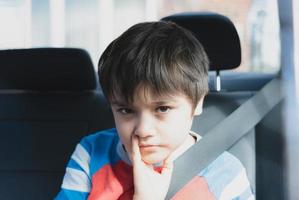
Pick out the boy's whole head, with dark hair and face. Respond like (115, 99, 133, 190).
(99, 22, 209, 164)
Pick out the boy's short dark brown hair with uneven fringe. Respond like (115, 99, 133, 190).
(98, 21, 209, 108)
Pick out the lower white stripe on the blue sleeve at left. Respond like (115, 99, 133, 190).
(61, 167, 91, 192)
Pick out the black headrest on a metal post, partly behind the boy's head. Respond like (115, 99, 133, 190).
(161, 12, 241, 70)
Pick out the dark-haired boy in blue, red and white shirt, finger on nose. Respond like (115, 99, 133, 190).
(56, 22, 254, 200)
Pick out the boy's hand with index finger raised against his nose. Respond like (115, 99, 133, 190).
(131, 136, 173, 200)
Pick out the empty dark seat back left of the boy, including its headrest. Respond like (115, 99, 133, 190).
(0, 48, 113, 199)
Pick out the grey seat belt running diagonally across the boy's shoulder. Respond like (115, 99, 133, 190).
(166, 77, 283, 200)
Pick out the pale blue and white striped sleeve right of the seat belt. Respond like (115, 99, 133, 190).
(200, 152, 253, 199)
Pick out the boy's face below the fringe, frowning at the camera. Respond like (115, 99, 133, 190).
(111, 87, 202, 164)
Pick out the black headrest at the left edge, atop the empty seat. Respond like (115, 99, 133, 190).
(0, 48, 97, 91)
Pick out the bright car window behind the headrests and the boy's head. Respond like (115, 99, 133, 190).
(0, 0, 280, 72)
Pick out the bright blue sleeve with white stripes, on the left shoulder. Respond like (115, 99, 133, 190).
(58, 129, 119, 197)
